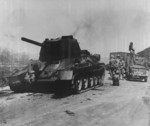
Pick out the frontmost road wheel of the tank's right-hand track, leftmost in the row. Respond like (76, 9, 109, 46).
(74, 77, 83, 93)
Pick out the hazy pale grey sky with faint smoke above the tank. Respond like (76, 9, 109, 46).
(0, 0, 150, 58)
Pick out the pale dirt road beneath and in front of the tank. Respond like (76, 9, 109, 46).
(0, 73, 150, 126)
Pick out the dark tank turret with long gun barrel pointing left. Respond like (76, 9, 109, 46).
(21, 36, 81, 62)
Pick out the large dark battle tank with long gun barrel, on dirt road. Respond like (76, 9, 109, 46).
(9, 36, 105, 93)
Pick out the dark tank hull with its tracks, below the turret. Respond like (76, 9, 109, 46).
(9, 60, 105, 93)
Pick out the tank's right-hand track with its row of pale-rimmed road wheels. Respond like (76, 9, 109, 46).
(72, 67, 105, 94)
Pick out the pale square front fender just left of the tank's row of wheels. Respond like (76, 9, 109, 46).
(58, 70, 73, 80)
